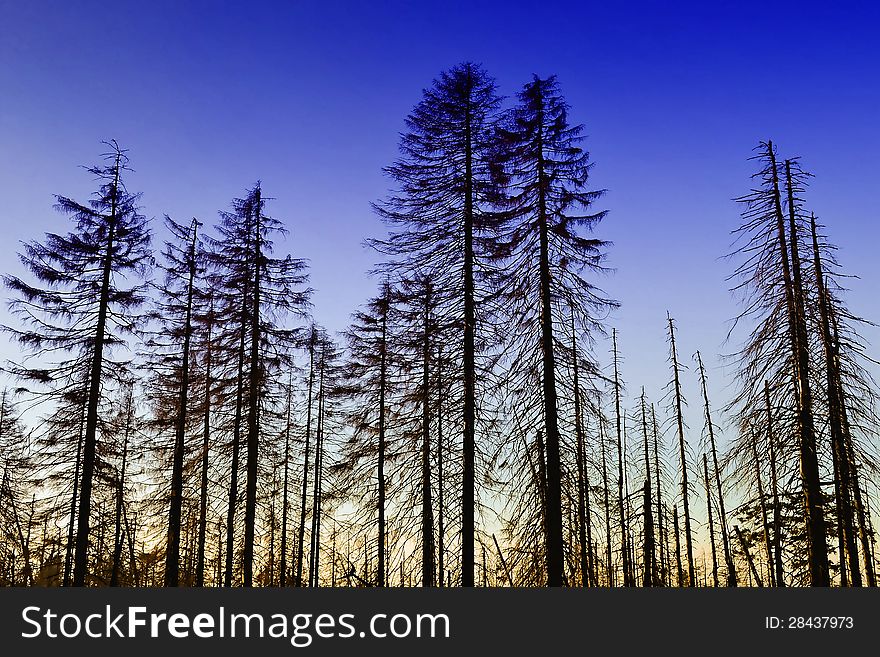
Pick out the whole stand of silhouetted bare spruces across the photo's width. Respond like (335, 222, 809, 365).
(0, 69, 880, 587)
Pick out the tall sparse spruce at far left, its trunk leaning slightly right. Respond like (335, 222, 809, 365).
(4, 141, 150, 586)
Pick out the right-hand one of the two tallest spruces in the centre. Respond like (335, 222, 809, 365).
(494, 76, 612, 586)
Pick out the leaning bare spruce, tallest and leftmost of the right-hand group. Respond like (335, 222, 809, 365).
(730, 141, 830, 586)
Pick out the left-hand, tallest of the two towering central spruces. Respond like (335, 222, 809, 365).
(372, 62, 500, 586)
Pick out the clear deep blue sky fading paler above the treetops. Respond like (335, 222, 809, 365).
(0, 0, 880, 438)
